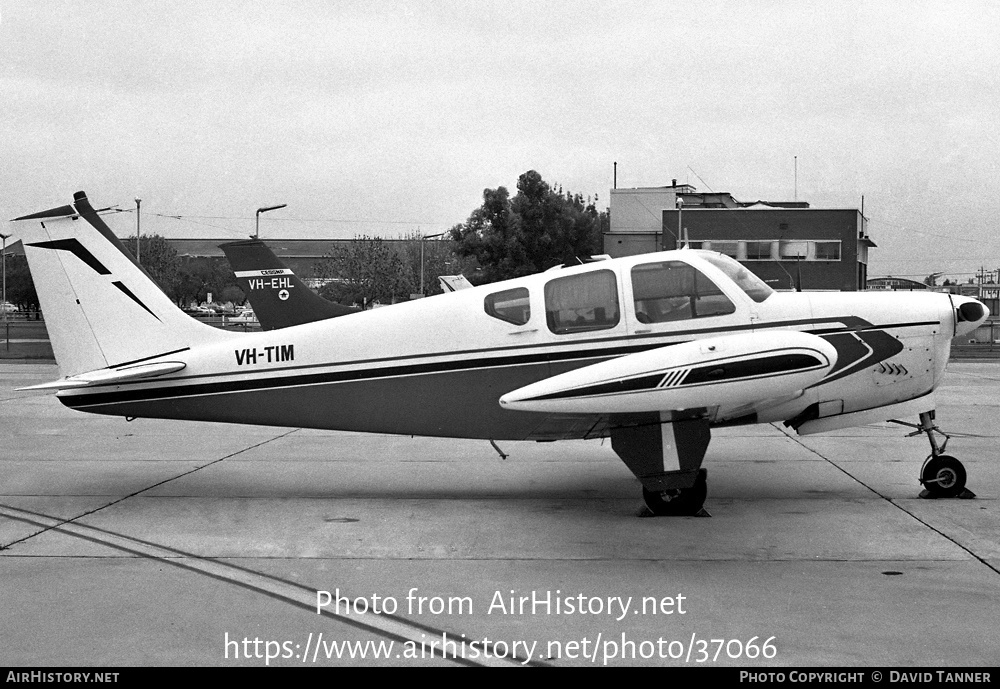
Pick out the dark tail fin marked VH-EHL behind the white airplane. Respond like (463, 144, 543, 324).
(219, 239, 358, 330)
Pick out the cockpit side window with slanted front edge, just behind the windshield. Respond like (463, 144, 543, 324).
(632, 261, 736, 323)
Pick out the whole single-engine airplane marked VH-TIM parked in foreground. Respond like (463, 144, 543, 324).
(9, 192, 989, 515)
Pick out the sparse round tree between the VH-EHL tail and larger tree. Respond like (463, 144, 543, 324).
(313, 236, 409, 309)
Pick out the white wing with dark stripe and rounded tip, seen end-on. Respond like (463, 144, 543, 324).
(500, 331, 837, 414)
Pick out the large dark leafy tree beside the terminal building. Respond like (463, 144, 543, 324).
(451, 170, 605, 282)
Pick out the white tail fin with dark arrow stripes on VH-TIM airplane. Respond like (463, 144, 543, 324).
(13, 191, 234, 376)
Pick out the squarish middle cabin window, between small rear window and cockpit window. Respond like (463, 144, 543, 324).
(545, 270, 621, 335)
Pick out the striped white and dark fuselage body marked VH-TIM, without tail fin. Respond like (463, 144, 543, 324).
(52, 251, 956, 440)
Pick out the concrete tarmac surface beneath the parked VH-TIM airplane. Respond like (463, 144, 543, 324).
(0, 362, 1000, 668)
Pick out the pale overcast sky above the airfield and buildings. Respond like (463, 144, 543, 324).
(0, 0, 1000, 277)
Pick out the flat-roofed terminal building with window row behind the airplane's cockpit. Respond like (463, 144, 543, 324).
(604, 180, 876, 291)
